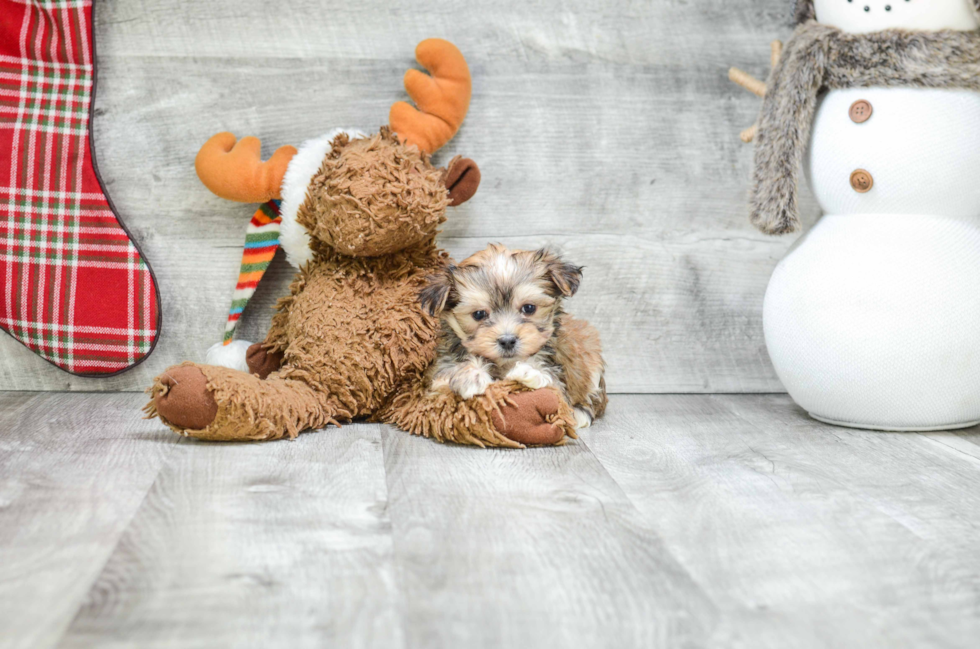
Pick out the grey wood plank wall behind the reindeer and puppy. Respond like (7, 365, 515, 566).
(0, 0, 815, 392)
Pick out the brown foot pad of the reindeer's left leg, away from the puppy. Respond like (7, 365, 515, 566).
(153, 365, 218, 430)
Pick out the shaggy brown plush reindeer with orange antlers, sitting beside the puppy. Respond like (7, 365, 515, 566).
(147, 39, 574, 447)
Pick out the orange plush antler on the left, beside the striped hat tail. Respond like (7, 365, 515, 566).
(194, 133, 296, 203)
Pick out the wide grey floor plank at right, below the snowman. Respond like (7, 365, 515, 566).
(582, 395, 980, 647)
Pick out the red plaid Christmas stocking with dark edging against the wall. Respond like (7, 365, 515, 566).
(0, 0, 160, 376)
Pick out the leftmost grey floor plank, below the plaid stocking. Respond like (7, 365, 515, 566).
(0, 393, 179, 649)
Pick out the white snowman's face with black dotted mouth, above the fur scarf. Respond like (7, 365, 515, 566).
(813, 0, 980, 34)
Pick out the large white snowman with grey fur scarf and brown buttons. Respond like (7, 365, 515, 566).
(731, 0, 980, 431)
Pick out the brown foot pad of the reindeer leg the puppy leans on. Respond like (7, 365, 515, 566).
(492, 390, 566, 446)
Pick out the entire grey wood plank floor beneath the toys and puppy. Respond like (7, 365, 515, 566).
(0, 393, 980, 648)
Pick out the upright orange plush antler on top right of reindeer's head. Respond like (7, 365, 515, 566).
(388, 38, 472, 153)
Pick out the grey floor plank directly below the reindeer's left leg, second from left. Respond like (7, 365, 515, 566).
(59, 425, 403, 649)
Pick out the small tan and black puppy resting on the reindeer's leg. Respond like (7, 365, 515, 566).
(420, 244, 607, 428)
